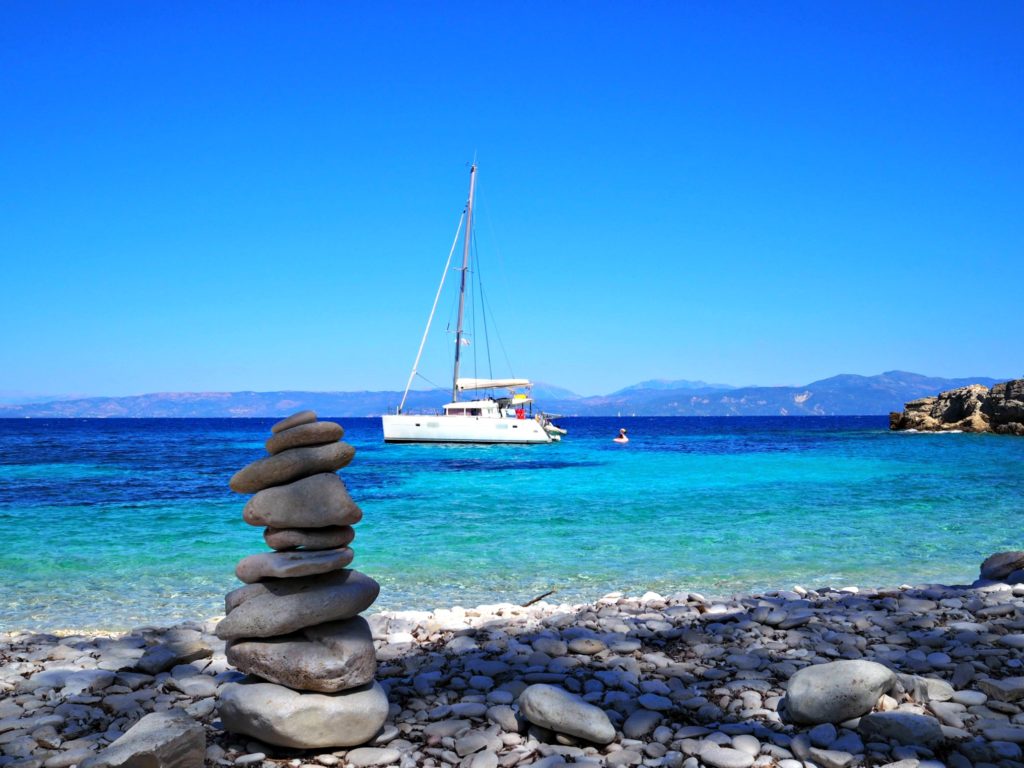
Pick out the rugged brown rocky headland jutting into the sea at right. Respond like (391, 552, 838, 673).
(889, 379, 1024, 435)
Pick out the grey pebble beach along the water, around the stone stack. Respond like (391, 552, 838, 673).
(6, 553, 1024, 768)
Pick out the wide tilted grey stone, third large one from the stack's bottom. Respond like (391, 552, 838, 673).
(217, 568, 381, 640)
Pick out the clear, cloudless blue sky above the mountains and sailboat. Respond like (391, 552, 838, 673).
(0, 2, 1024, 403)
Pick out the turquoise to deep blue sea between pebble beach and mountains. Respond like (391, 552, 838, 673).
(0, 416, 1024, 630)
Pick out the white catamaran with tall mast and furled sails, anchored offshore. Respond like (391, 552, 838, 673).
(382, 164, 565, 443)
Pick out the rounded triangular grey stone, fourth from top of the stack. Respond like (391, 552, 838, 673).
(242, 472, 362, 528)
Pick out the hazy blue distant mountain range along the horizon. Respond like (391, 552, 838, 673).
(0, 371, 1005, 419)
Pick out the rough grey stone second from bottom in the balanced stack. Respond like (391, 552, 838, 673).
(227, 616, 377, 693)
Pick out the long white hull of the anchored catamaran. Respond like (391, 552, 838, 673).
(382, 414, 552, 444)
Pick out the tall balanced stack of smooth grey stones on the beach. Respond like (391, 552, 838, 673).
(217, 411, 388, 749)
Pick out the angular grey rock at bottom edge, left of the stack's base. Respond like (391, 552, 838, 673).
(78, 710, 206, 768)
